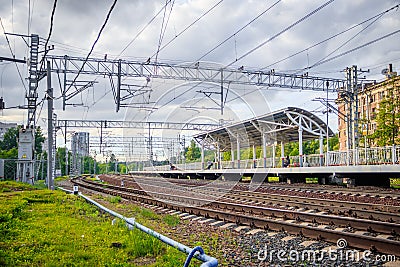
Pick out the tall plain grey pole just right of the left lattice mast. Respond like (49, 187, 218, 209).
(47, 61, 54, 190)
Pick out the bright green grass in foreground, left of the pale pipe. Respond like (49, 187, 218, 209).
(0, 182, 186, 266)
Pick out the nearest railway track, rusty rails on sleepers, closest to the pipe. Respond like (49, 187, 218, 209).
(73, 177, 400, 256)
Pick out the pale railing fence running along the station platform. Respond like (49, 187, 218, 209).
(144, 146, 400, 171)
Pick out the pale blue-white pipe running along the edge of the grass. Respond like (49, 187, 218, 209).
(57, 187, 218, 267)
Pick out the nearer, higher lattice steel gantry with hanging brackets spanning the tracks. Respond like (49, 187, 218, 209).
(46, 55, 346, 113)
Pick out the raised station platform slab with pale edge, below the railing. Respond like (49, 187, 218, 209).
(130, 164, 400, 186)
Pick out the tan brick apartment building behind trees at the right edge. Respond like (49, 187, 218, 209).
(337, 64, 400, 150)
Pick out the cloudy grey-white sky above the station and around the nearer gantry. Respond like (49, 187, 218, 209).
(0, 0, 400, 159)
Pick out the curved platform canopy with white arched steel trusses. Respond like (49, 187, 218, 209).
(194, 107, 334, 151)
